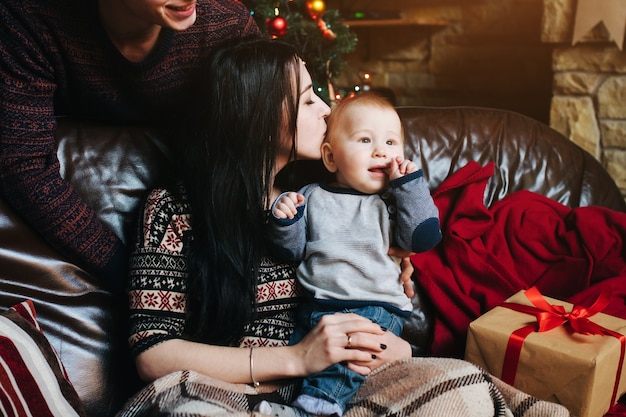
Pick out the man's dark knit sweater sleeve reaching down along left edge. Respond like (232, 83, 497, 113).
(0, 2, 127, 287)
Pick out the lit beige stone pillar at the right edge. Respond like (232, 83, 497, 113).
(542, 0, 626, 197)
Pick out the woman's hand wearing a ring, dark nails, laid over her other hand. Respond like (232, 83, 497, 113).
(295, 313, 382, 375)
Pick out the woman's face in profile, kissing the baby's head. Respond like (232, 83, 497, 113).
(277, 60, 330, 169)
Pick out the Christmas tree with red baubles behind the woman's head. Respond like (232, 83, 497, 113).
(243, 0, 357, 103)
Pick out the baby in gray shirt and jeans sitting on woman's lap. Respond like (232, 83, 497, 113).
(269, 92, 441, 416)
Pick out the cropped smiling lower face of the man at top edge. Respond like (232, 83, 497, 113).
(117, 0, 196, 31)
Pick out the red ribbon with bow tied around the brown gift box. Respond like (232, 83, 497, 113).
(502, 285, 626, 405)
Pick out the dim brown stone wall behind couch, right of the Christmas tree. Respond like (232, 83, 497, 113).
(327, 0, 552, 123)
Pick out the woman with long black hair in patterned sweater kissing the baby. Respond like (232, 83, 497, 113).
(120, 39, 572, 416)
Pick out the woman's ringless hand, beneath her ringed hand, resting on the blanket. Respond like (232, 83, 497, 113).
(347, 331, 412, 375)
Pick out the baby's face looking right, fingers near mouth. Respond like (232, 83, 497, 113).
(327, 105, 404, 194)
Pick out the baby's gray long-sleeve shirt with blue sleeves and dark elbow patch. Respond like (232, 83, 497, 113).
(269, 170, 441, 311)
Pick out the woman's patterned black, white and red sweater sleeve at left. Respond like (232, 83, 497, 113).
(128, 189, 191, 356)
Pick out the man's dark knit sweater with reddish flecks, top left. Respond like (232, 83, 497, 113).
(0, 0, 258, 287)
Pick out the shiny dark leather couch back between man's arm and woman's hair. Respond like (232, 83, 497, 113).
(56, 119, 168, 243)
